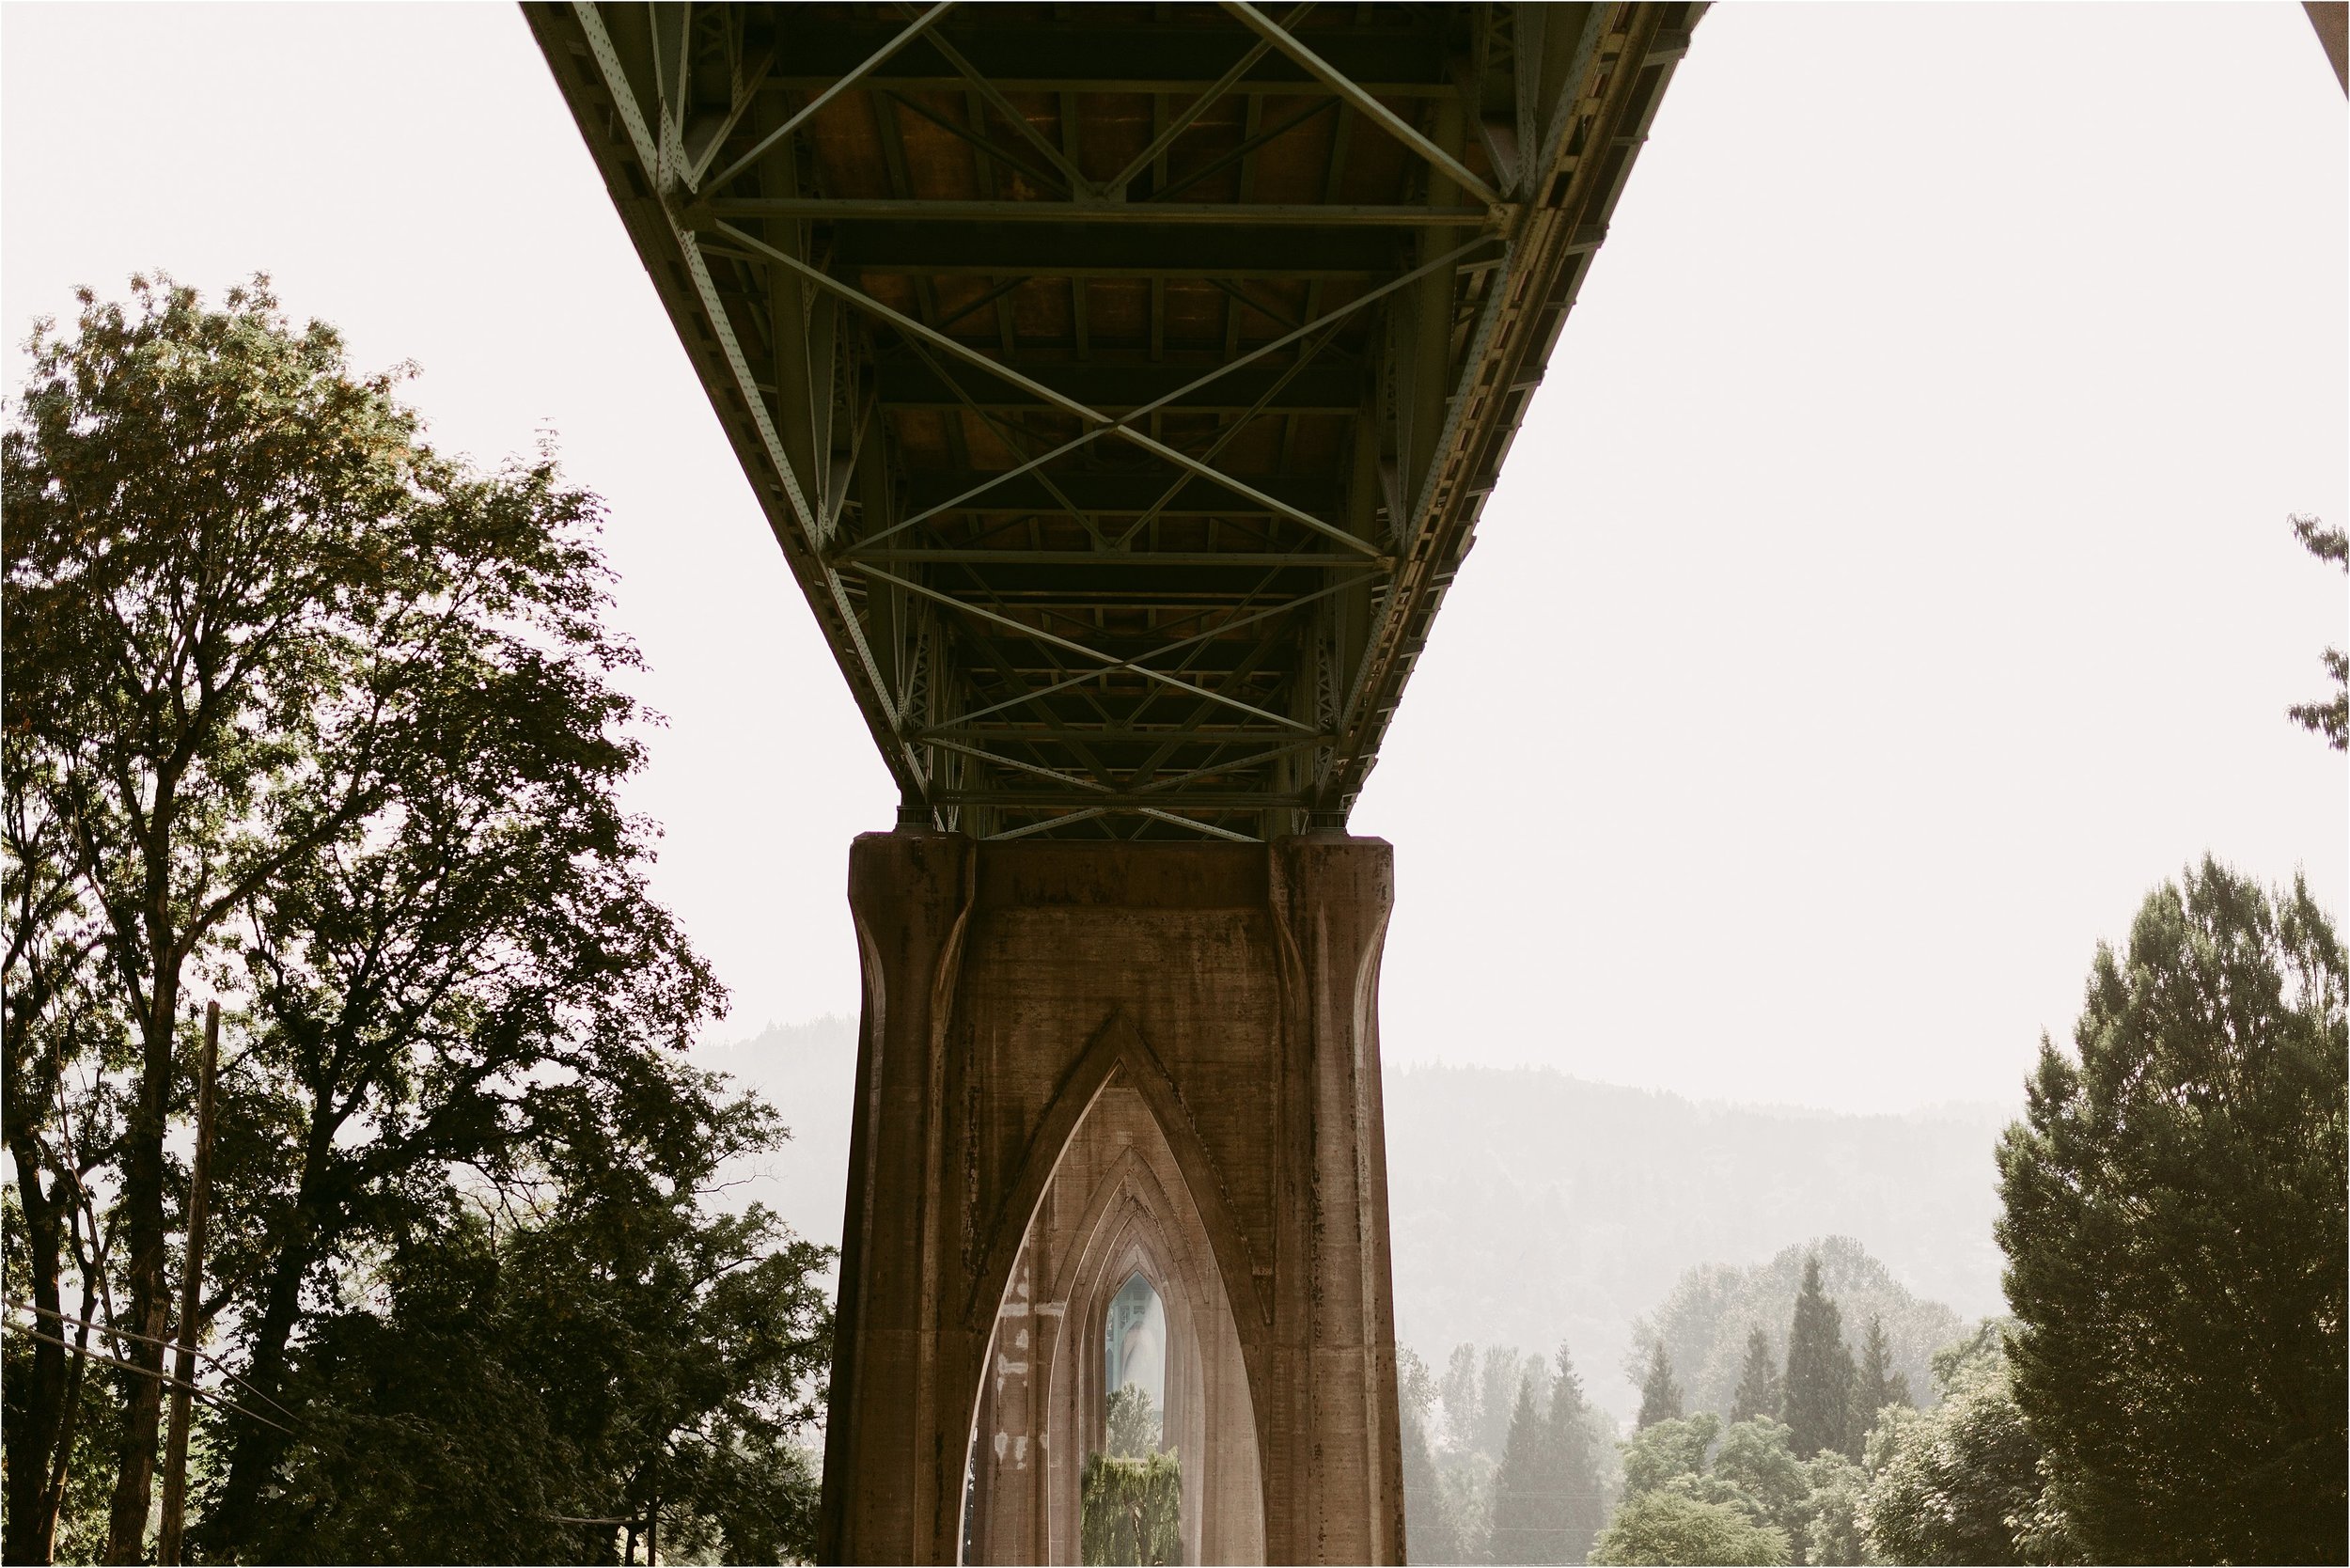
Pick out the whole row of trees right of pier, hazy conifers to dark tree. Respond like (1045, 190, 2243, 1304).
(1403, 858, 2350, 1563)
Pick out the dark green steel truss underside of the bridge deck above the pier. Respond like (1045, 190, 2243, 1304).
(525, 0, 1704, 839)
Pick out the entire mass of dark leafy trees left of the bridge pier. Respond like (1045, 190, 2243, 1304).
(0, 280, 830, 1560)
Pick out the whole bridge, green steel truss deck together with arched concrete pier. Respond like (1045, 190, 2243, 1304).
(525, 0, 1701, 1563)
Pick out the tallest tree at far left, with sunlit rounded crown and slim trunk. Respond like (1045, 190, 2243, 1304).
(0, 280, 512, 1560)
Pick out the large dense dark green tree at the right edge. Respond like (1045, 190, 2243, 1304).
(1998, 858, 2350, 1563)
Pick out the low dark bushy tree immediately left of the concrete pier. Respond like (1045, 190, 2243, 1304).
(249, 1105, 830, 1563)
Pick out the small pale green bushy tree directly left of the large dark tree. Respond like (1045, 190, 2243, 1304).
(1859, 1321, 2080, 1563)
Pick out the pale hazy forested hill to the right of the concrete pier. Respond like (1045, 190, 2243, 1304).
(1386, 1067, 2012, 1418)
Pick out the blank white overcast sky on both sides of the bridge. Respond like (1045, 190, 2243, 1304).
(0, 3, 2350, 1109)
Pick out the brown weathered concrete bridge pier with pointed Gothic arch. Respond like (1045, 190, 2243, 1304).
(818, 832, 1403, 1563)
